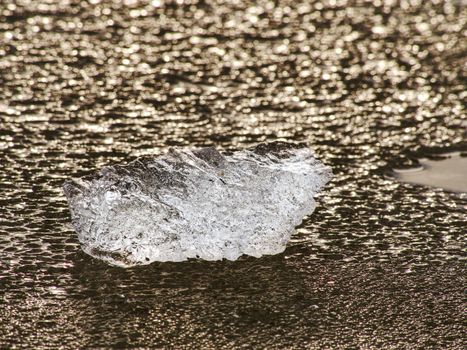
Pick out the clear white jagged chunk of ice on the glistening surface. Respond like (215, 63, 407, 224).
(63, 142, 332, 266)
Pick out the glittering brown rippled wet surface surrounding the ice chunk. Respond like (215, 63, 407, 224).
(0, 0, 467, 349)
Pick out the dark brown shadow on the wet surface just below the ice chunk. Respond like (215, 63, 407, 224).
(66, 252, 336, 346)
